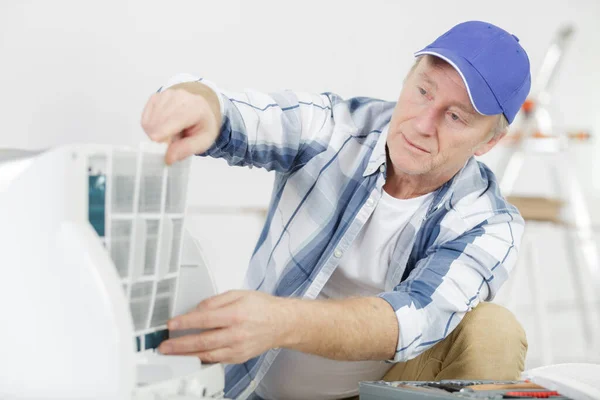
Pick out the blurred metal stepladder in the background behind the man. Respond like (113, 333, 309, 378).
(498, 26, 600, 365)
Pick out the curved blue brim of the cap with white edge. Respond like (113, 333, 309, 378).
(415, 48, 504, 115)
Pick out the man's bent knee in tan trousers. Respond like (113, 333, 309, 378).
(436, 303, 527, 380)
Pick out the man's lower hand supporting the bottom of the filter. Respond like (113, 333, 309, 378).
(159, 290, 290, 364)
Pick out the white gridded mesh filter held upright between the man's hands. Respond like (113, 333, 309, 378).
(99, 149, 190, 342)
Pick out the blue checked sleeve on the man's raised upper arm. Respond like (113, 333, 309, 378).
(159, 74, 340, 173)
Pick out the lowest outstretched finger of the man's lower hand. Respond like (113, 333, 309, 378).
(158, 328, 236, 354)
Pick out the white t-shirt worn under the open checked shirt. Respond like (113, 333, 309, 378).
(256, 191, 433, 400)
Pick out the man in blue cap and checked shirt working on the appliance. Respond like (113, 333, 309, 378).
(142, 21, 530, 399)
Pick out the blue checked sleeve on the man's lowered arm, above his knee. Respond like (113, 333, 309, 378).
(379, 212, 524, 362)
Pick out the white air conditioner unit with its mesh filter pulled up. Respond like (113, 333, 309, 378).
(0, 145, 224, 400)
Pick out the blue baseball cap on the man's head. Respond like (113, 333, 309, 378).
(415, 21, 531, 123)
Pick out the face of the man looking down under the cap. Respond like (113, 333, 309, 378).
(387, 57, 498, 176)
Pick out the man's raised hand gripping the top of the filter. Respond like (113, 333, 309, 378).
(142, 82, 221, 165)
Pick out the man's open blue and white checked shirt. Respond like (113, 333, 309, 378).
(161, 76, 524, 399)
